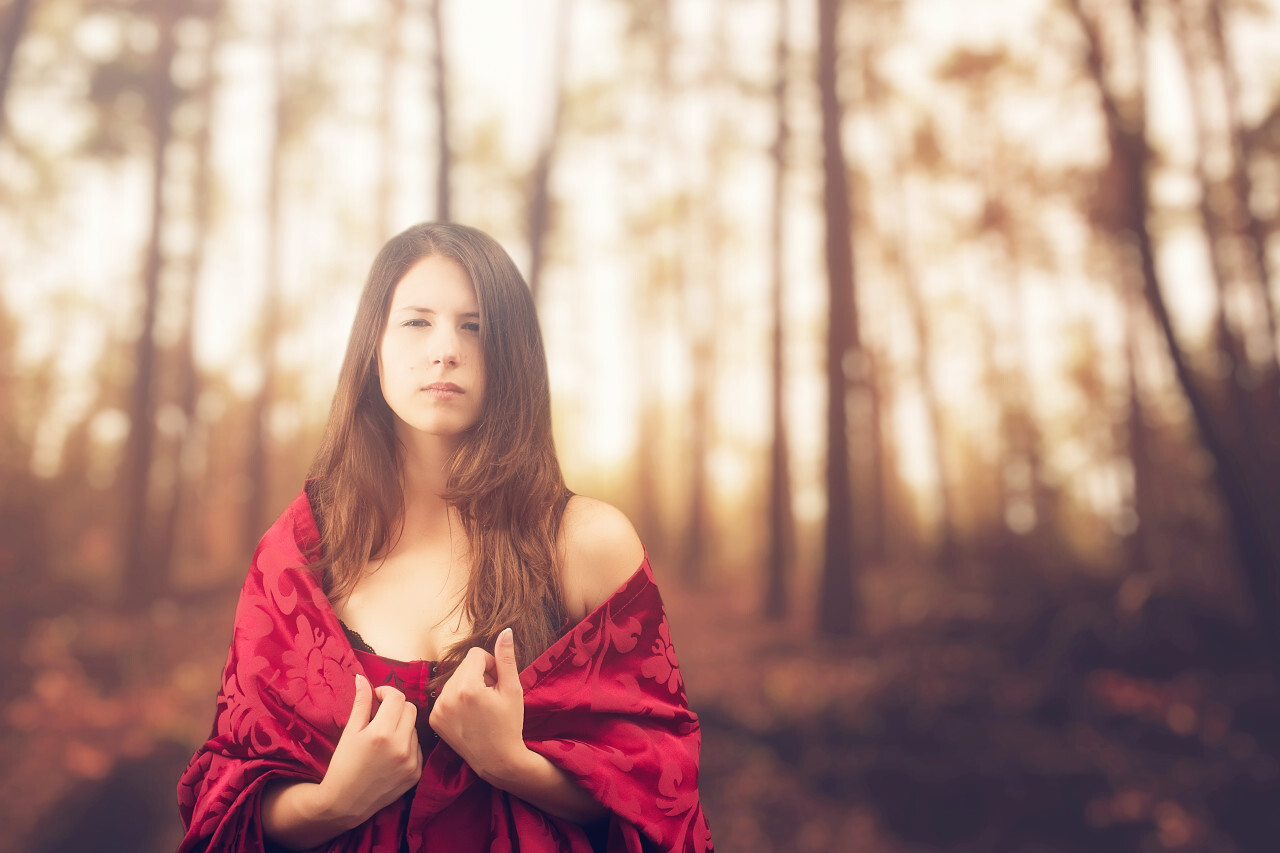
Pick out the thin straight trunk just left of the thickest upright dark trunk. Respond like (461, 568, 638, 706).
(763, 0, 795, 619)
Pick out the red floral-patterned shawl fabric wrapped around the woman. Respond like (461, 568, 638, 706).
(178, 494, 712, 853)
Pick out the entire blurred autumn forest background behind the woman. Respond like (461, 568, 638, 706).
(0, 0, 1280, 853)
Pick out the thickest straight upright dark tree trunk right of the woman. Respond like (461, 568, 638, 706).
(818, 0, 860, 635)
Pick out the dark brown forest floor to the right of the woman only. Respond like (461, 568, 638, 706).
(668, 558, 1280, 853)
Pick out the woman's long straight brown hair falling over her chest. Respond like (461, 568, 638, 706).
(307, 223, 571, 675)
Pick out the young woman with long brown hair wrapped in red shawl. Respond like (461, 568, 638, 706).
(178, 223, 712, 853)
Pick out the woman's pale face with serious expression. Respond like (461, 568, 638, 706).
(378, 255, 484, 439)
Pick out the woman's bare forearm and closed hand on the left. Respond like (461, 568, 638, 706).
(261, 675, 422, 850)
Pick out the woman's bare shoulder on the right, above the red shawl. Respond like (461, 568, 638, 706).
(561, 494, 644, 620)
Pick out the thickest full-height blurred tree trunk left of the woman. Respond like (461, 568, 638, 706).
(119, 4, 178, 610)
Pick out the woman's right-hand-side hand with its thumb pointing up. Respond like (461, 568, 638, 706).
(430, 628, 529, 783)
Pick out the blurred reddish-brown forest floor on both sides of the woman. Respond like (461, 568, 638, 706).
(0, 558, 1280, 853)
